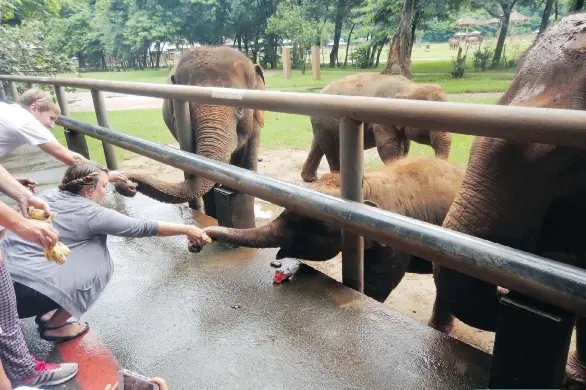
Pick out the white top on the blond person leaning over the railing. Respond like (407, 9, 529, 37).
(0, 102, 57, 157)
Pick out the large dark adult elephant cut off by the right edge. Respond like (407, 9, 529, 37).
(430, 13, 586, 385)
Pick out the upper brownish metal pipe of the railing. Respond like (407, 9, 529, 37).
(0, 75, 586, 148)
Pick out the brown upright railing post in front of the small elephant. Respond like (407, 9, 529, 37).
(340, 117, 364, 293)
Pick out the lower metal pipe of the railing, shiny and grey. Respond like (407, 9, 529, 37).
(57, 116, 586, 316)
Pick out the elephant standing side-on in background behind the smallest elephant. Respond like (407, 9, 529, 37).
(301, 72, 452, 182)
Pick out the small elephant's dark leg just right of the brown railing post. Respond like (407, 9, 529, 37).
(364, 246, 411, 302)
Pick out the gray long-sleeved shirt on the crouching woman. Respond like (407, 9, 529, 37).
(0, 189, 158, 318)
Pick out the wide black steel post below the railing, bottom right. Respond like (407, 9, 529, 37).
(488, 292, 574, 389)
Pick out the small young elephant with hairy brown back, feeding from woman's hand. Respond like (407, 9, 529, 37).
(204, 157, 465, 302)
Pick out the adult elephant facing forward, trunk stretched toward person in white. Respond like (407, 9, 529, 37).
(117, 47, 265, 216)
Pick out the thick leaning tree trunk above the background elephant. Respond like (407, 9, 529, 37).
(381, 0, 415, 79)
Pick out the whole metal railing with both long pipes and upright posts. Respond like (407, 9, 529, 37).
(0, 75, 586, 387)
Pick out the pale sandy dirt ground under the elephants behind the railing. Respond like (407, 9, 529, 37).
(121, 145, 494, 353)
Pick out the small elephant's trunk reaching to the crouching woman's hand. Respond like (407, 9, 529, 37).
(204, 216, 288, 248)
